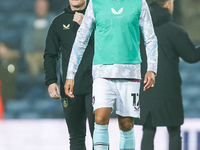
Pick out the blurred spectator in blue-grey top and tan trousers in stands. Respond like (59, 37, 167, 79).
(22, 0, 54, 77)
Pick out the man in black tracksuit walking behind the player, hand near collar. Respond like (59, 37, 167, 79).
(44, 0, 94, 150)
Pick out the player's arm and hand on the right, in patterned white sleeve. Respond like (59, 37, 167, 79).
(139, 0, 158, 91)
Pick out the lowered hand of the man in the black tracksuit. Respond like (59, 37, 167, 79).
(48, 83, 60, 99)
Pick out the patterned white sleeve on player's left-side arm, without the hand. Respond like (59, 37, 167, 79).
(66, 1, 95, 79)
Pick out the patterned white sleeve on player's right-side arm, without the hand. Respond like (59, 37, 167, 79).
(139, 0, 158, 73)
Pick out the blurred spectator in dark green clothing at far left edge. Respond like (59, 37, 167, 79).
(0, 43, 20, 104)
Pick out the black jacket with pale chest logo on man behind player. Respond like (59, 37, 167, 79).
(44, 6, 94, 94)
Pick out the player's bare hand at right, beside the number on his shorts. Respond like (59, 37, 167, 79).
(143, 71, 155, 91)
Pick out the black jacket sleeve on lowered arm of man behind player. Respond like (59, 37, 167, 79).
(44, 22, 60, 86)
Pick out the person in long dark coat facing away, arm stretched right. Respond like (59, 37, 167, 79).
(135, 0, 200, 150)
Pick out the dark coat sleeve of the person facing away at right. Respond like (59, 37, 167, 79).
(170, 26, 200, 63)
